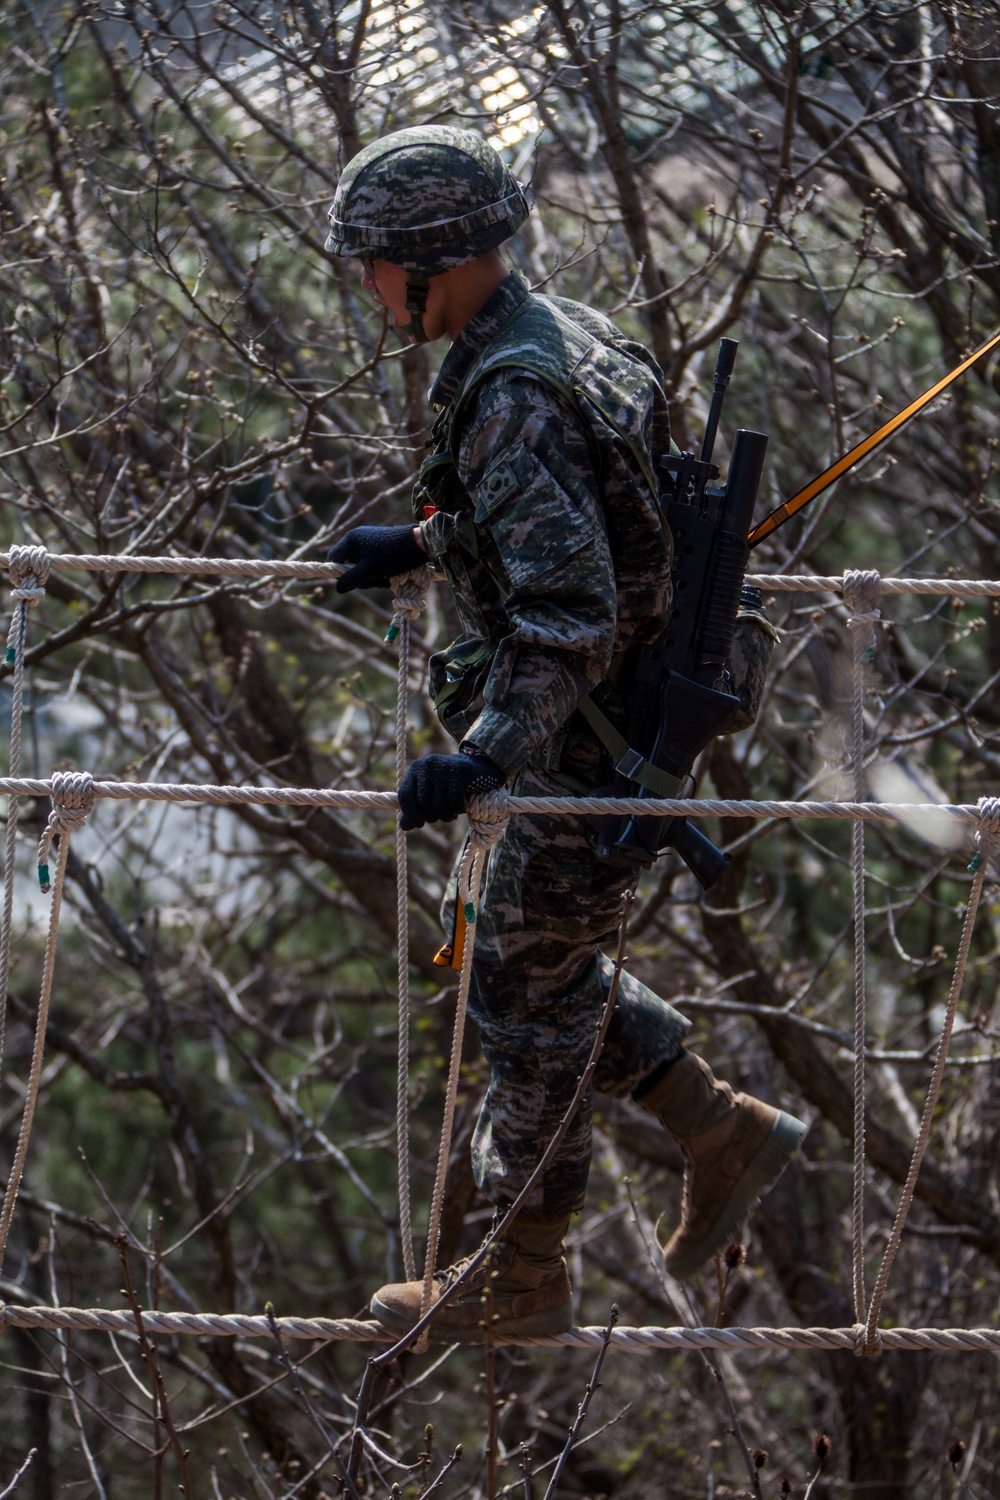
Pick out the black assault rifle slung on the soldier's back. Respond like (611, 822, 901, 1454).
(582, 339, 768, 891)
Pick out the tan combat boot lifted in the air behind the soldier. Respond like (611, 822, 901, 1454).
(637, 1052, 805, 1277)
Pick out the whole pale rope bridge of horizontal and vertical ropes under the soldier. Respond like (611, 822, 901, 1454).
(0, 546, 1000, 1356)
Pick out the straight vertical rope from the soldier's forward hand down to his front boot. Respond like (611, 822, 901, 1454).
(385, 567, 430, 1281)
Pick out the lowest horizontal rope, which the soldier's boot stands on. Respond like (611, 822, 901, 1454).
(0, 1307, 1000, 1355)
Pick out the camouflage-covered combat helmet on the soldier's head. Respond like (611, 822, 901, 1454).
(327, 125, 528, 276)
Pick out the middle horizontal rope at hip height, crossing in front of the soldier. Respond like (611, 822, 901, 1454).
(0, 776, 979, 824)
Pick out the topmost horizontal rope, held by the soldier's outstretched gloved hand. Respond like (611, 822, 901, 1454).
(0, 552, 1000, 599)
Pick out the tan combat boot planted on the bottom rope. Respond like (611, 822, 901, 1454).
(372, 1217, 573, 1344)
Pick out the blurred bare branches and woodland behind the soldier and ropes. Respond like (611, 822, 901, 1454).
(0, 0, 1000, 1500)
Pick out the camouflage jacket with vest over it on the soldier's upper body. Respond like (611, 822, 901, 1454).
(414, 273, 672, 776)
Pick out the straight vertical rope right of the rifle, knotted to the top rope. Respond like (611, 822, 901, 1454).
(844, 573, 882, 1323)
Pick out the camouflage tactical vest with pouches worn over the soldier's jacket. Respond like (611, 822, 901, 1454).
(414, 296, 777, 797)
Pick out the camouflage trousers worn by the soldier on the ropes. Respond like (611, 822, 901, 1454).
(458, 767, 690, 1218)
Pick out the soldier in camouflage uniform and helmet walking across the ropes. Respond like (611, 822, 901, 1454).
(327, 126, 805, 1341)
